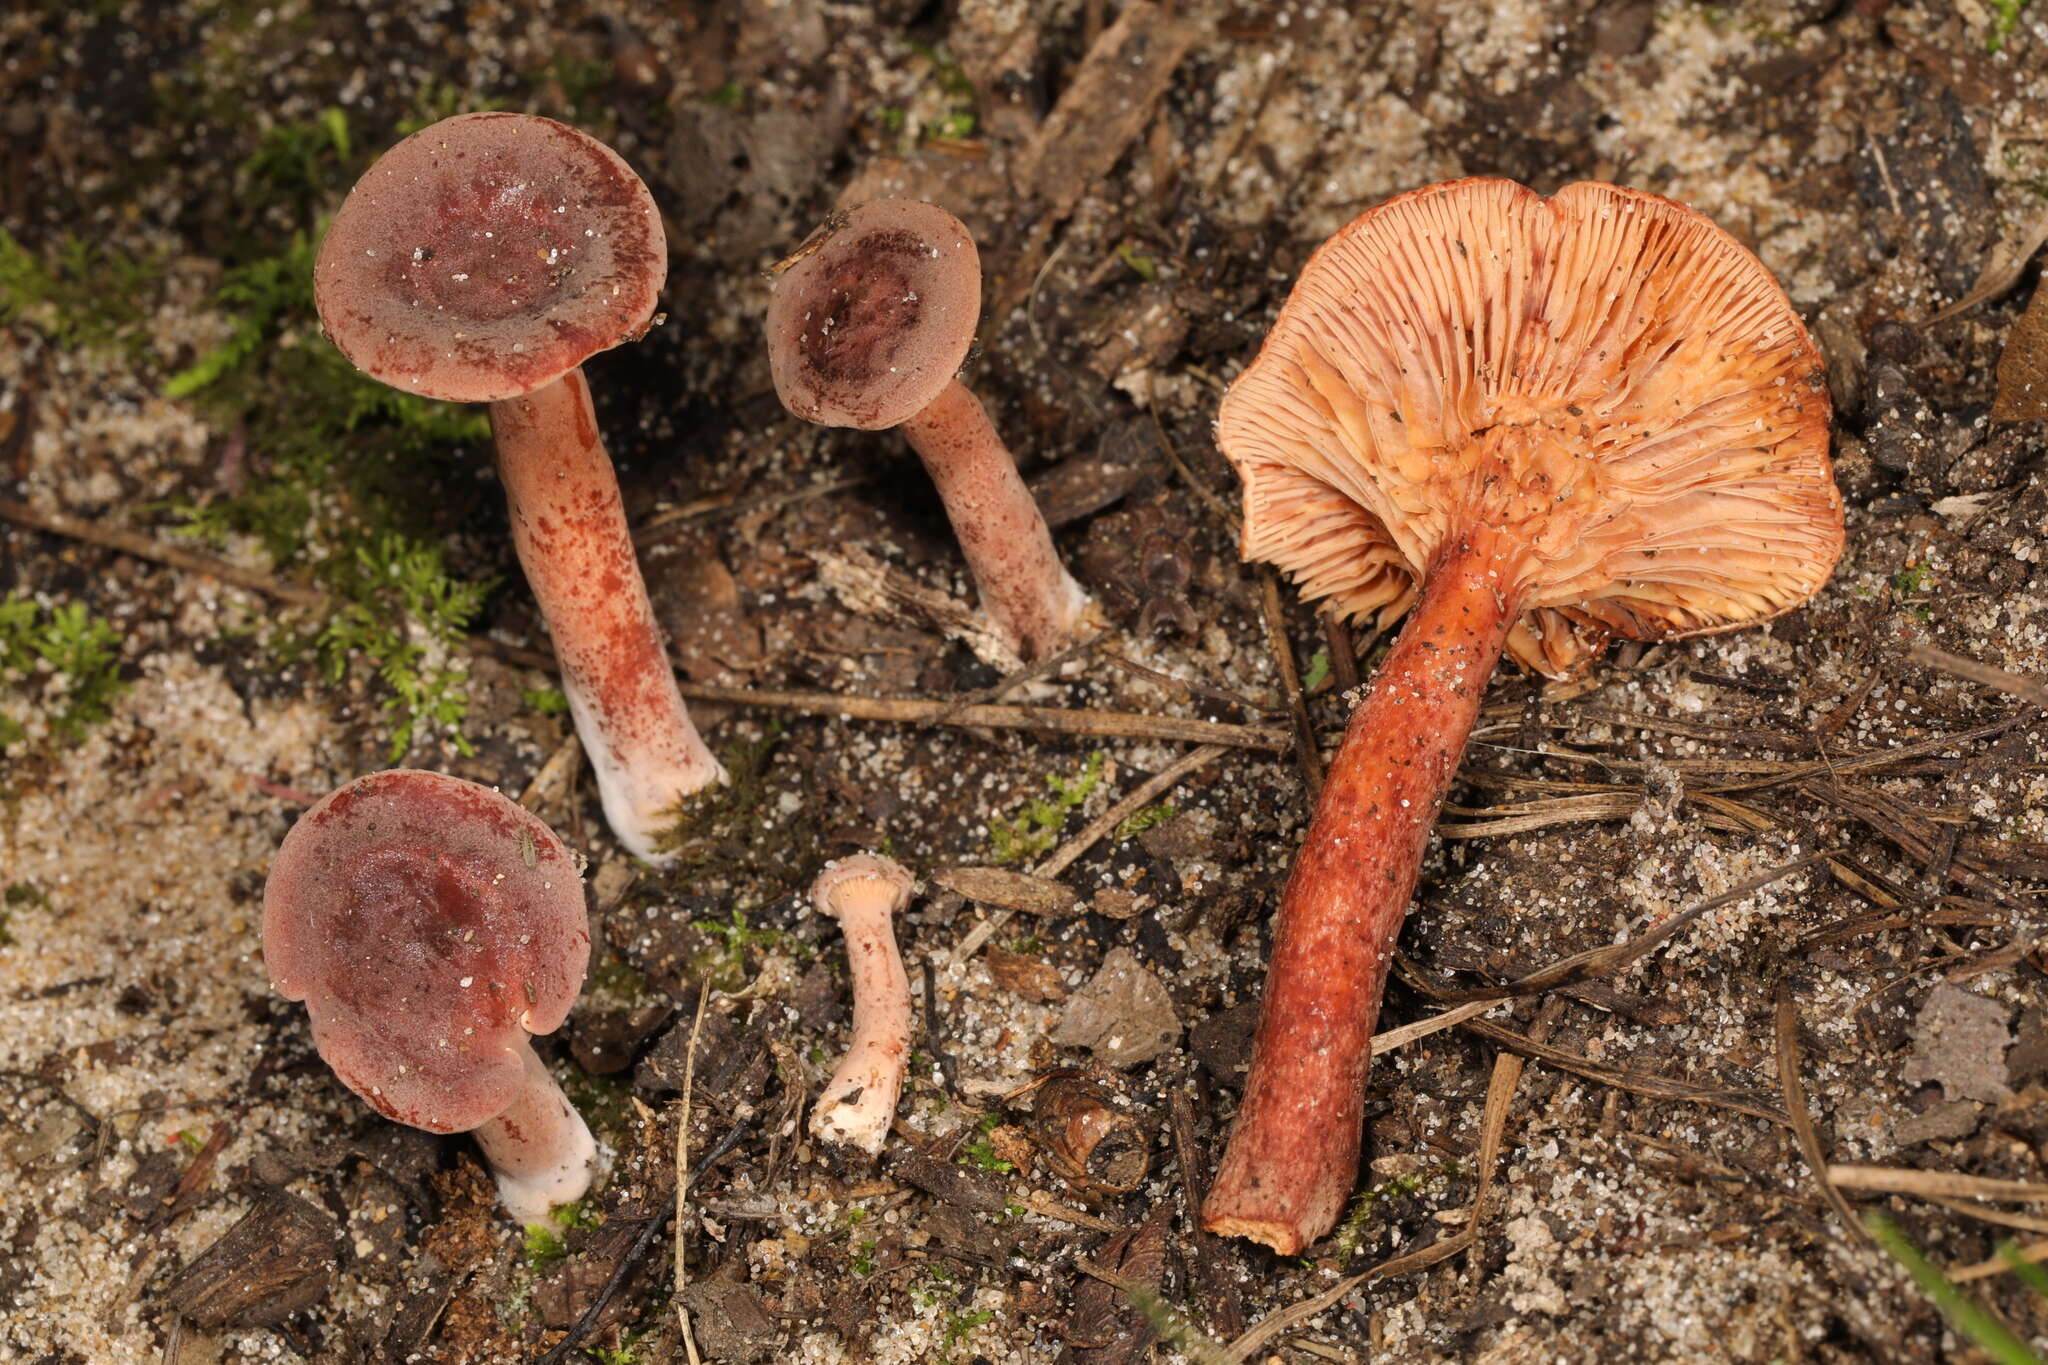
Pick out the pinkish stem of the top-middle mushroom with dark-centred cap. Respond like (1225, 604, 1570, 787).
(901, 379, 1087, 659)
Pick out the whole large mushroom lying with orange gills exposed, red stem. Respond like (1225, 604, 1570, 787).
(1202, 180, 1843, 1254)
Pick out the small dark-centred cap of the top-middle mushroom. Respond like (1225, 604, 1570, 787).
(768, 199, 981, 432)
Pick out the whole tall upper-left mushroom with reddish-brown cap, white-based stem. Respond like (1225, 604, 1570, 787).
(313, 115, 725, 862)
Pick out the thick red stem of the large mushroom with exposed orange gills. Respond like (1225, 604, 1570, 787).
(1202, 530, 1522, 1257)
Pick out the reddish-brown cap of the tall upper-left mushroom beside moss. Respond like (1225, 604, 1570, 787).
(313, 115, 668, 403)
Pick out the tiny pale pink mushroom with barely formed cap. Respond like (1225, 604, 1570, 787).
(811, 853, 918, 1156)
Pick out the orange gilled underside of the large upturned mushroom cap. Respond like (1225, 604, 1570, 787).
(1217, 180, 1843, 675)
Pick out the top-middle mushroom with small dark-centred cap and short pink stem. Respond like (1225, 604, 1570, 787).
(768, 199, 1090, 659)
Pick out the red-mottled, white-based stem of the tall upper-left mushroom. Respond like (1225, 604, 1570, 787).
(489, 366, 725, 862)
